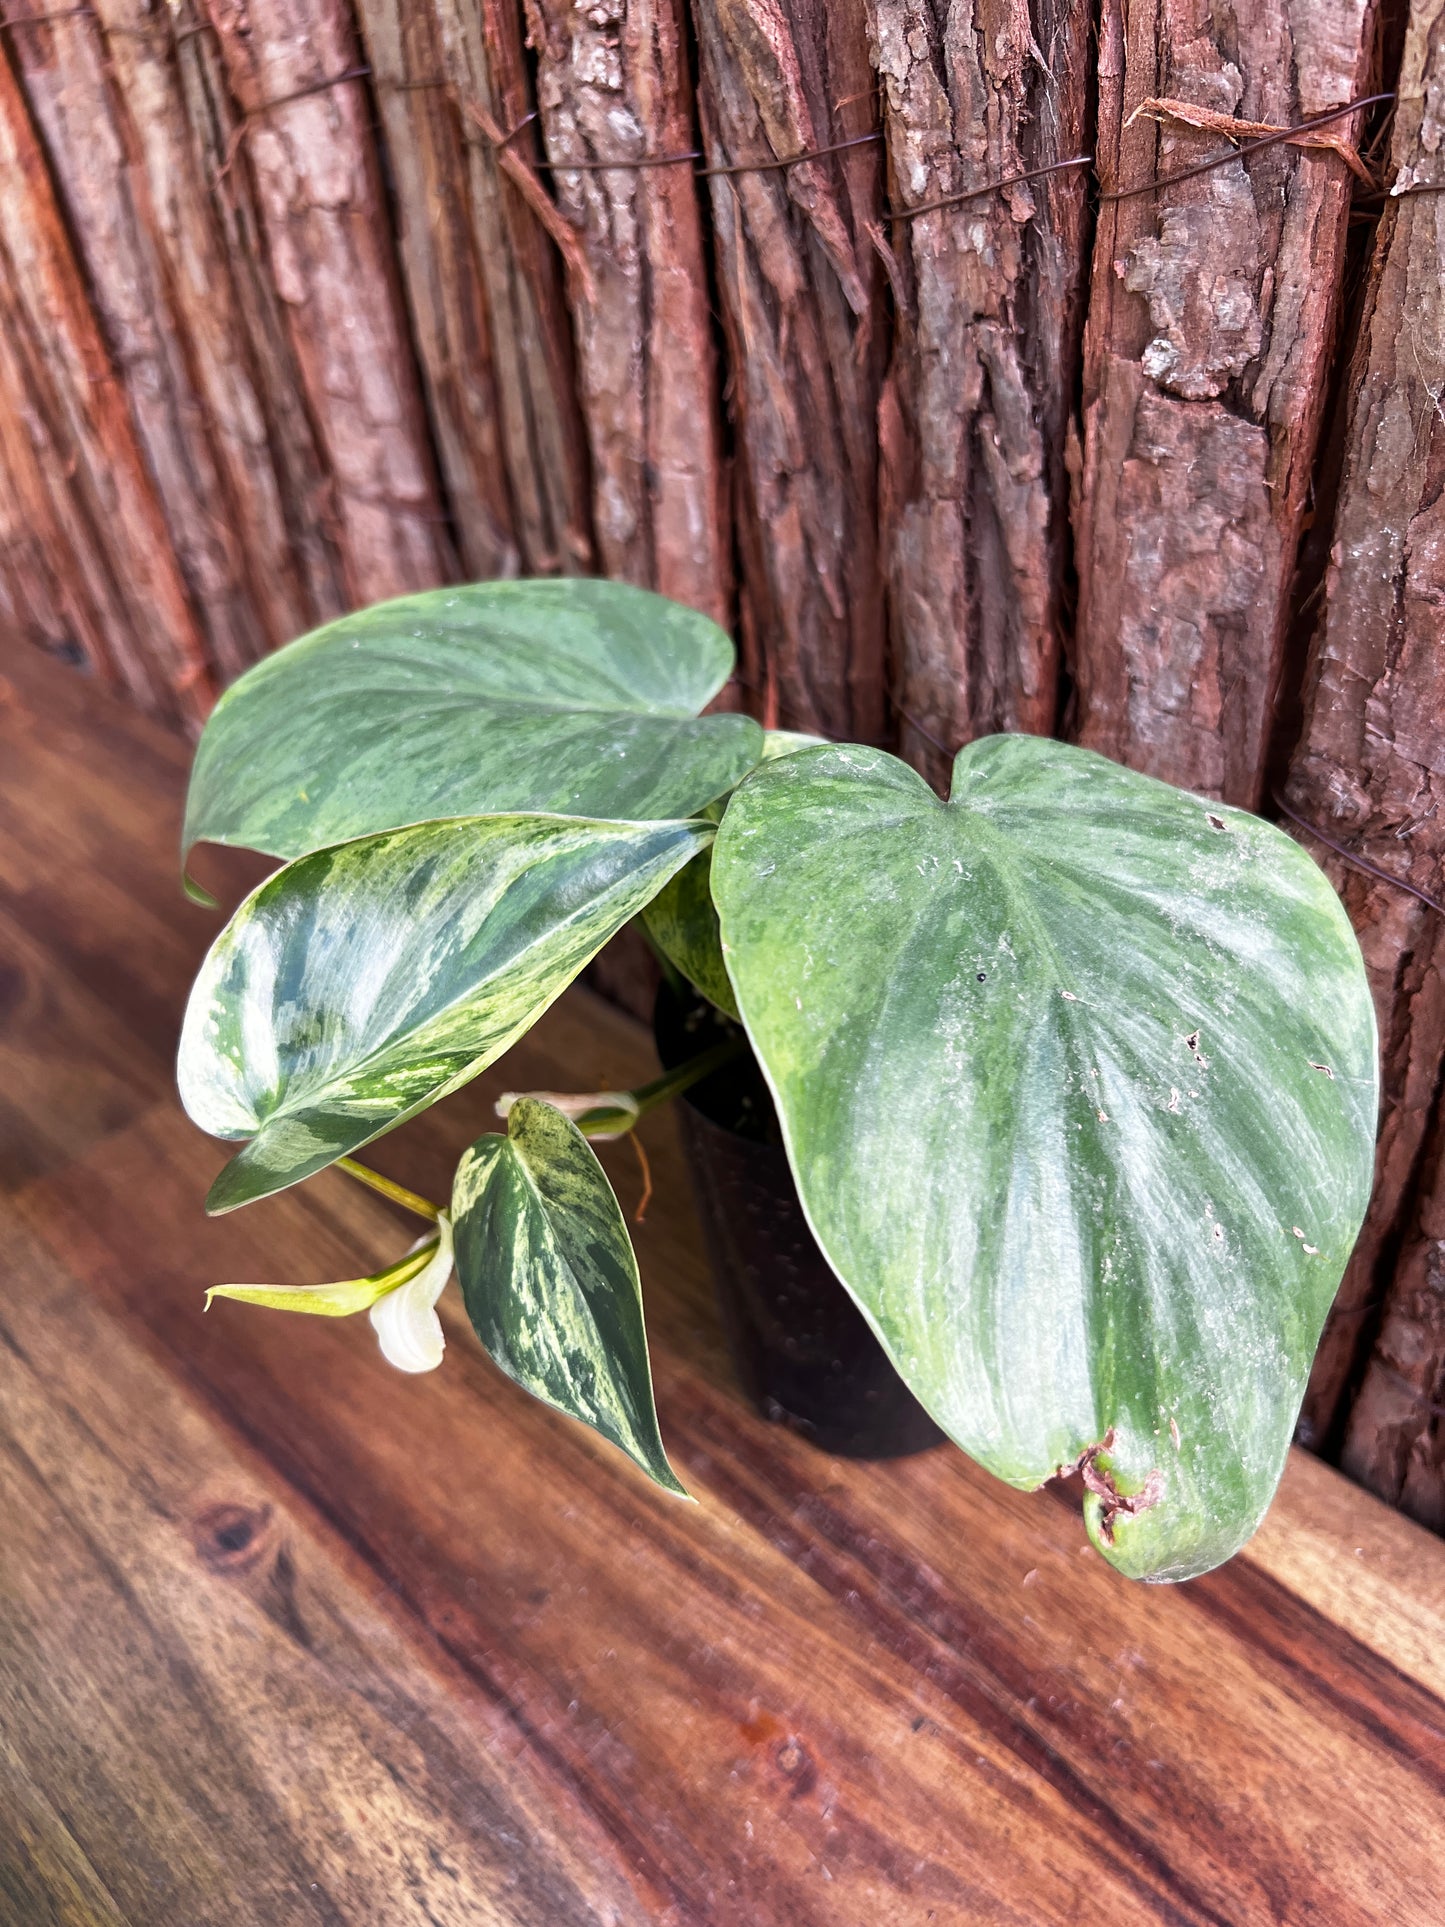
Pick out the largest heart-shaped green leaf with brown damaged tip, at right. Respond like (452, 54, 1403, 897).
(713, 736, 1376, 1578)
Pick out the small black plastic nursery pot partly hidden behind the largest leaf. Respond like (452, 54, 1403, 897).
(653, 983, 944, 1459)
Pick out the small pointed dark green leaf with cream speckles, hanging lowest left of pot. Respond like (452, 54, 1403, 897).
(451, 1096, 686, 1495)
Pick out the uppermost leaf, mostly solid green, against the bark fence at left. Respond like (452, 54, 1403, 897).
(183, 580, 763, 858)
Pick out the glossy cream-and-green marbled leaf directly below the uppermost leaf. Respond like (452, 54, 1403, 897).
(179, 815, 713, 1212)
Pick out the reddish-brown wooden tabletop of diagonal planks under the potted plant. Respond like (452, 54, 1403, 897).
(0, 649, 1445, 1927)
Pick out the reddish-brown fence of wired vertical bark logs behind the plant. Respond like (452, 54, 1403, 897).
(0, 0, 1445, 1530)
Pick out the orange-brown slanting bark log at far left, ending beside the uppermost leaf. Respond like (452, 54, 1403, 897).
(0, 48, 210, 723)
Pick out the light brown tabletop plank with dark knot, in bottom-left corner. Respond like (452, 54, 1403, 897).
(0, 1226, 639, 1927)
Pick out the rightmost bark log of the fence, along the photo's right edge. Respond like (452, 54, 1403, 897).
(1289, 0, 1445, 1526)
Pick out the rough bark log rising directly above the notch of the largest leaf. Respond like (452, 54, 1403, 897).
(869, 0, 1090, 779)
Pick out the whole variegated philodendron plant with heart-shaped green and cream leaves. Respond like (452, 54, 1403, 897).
(179, 582, 1378, 1578)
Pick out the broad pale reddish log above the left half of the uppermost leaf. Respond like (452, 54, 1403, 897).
(206, 0, 457, 603)
